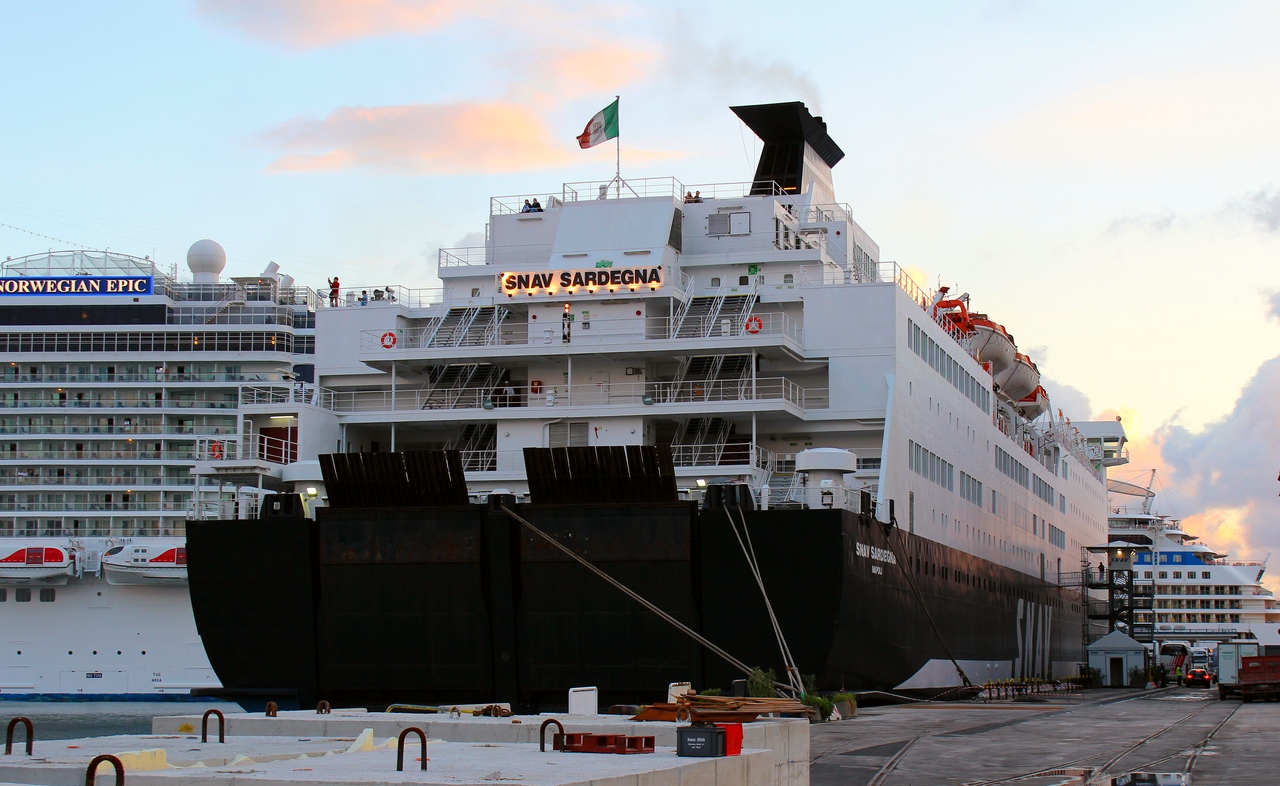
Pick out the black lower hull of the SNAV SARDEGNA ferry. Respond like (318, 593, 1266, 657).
(187, 503, 1083, 708)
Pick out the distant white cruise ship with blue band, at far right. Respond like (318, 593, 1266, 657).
(1107, 476, 1280, 646)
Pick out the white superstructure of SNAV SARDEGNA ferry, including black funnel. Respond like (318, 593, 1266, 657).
(282, 104, 1123, 581)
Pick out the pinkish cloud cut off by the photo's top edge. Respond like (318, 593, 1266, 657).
(196, 0, 502, 49)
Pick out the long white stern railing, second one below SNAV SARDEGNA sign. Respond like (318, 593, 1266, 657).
(325, 376, 827, 414)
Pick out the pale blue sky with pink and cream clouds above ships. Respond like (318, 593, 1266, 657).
(0, 0, 1280, 573)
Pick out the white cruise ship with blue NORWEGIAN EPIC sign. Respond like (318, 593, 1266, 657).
(0, 241, 316, 698)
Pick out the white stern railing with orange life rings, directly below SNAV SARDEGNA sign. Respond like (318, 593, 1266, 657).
(360, 312, 804, 353)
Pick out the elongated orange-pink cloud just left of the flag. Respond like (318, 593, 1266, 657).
(257, 102, 571, 174)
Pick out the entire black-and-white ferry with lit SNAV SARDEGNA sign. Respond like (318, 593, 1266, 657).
(180, 102, 1125, 704)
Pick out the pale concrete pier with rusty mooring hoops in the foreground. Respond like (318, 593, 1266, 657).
(0, 709, 809, 786)
